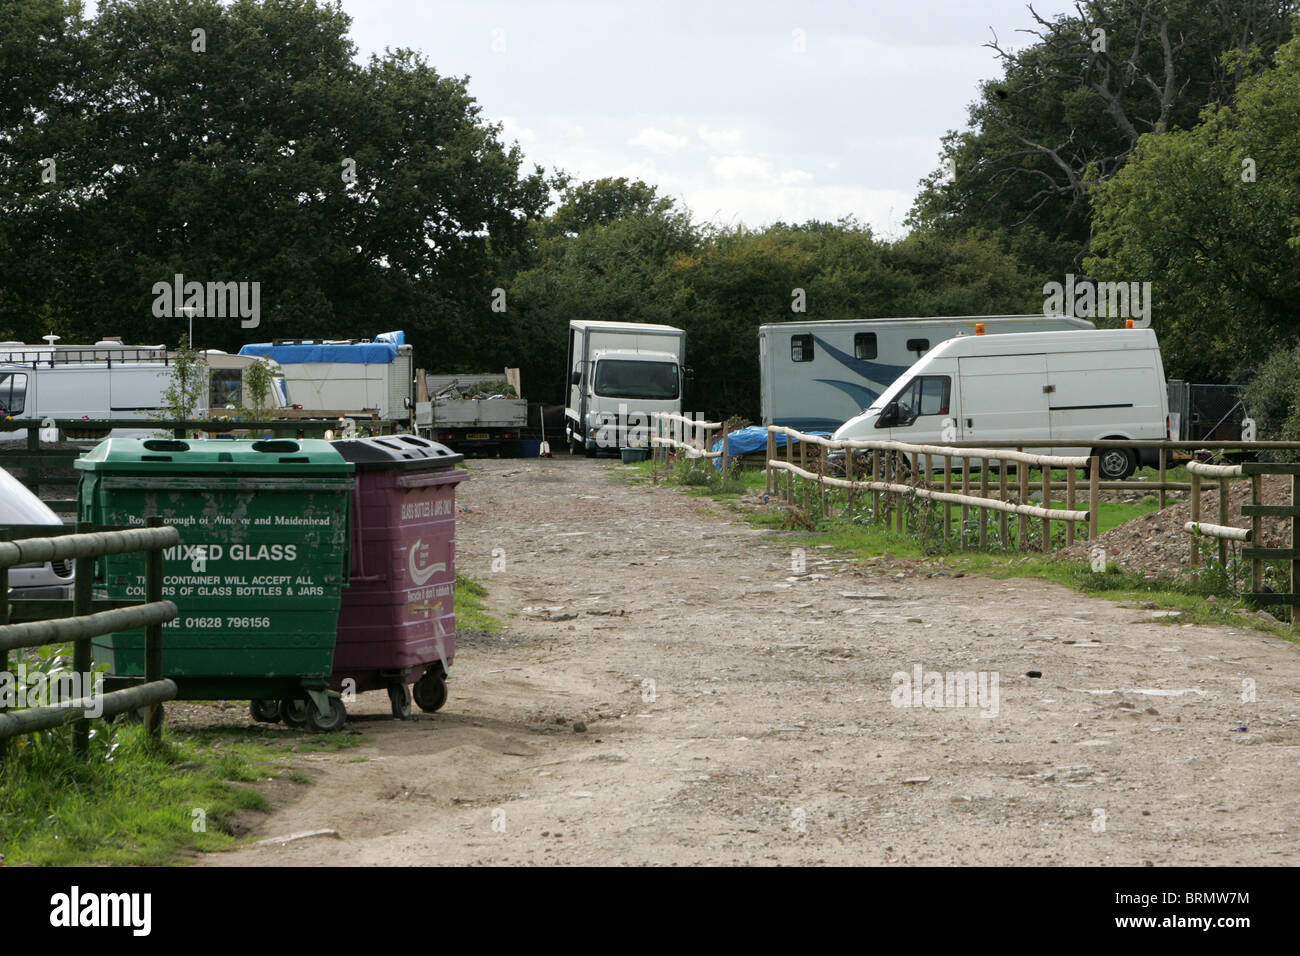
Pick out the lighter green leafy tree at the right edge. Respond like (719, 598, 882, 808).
(1087, 38, 1300, 378)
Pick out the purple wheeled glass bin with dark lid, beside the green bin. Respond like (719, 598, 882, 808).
(330, 434, 469, 717)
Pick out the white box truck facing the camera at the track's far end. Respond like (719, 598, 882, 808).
(564, 320, 690, 457)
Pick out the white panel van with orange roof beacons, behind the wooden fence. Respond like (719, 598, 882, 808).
(835, 329, 1169, 480)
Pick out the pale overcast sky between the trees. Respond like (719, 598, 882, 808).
(343, 0, 1073, 237)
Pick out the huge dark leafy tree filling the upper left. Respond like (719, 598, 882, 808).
(0, 0, 549, 352)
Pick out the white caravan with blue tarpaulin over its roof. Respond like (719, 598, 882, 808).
(239, 332, 415, 420)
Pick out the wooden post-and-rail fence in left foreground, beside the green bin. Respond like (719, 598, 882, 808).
(0, 516, 181, 757)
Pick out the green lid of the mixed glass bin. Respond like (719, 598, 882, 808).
(73, 438, 352, 475)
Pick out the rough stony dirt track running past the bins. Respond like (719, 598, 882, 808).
(203, 455, 1300, 865)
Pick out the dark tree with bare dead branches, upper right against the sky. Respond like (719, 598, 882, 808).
(909, 0, 1300, 276)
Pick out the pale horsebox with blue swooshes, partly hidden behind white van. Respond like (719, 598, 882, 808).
(758, 315, 1093, 432)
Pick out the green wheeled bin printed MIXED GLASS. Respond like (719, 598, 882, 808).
(75, 438, 354, 731)
